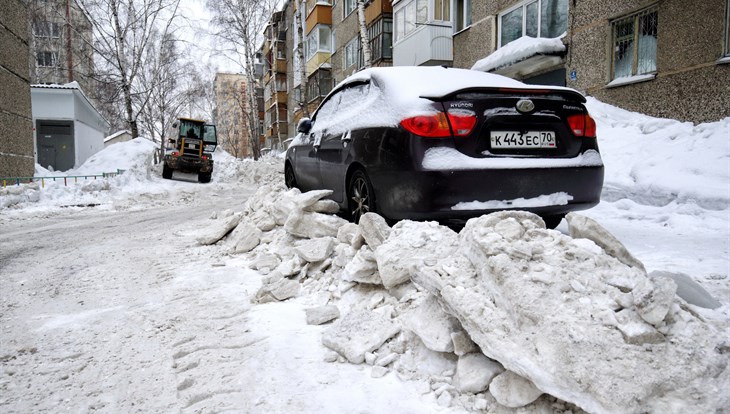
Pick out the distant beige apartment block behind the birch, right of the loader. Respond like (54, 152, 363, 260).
(213, 73, 251, 158)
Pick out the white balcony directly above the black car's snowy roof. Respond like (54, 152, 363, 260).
(393, 23, 454, 66)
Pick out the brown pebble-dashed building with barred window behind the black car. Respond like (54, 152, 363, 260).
(452, 0, 730, 122)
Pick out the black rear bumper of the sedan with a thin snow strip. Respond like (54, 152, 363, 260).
(371, 165, 604, 221)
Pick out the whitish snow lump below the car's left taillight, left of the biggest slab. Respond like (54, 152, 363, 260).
(375, 220, 458, 289)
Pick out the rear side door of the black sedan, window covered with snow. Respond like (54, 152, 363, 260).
(317, 83, 369, 203)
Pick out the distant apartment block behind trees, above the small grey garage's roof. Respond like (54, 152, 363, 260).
(28, 0, 94, 92)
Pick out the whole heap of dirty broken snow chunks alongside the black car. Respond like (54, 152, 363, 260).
(191, 186, 730, 413)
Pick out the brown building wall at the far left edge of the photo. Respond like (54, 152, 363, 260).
(0, 0, 35, 177)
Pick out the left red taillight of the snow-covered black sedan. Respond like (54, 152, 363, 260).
(400, 111, 477, 138)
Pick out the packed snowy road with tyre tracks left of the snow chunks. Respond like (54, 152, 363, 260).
(0, 183, 262, 413)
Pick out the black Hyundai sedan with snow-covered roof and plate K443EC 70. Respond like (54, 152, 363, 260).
(285, 67, 603, 227)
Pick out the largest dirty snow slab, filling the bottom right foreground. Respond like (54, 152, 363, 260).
(410, 212, 730, 413)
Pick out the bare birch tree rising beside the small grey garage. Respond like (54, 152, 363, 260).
(77, 0, 180, 138)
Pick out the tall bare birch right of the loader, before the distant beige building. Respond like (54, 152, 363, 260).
(212, 0, 277, 160)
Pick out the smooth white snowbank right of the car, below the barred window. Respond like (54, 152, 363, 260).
(586, 97, 730, 210)
